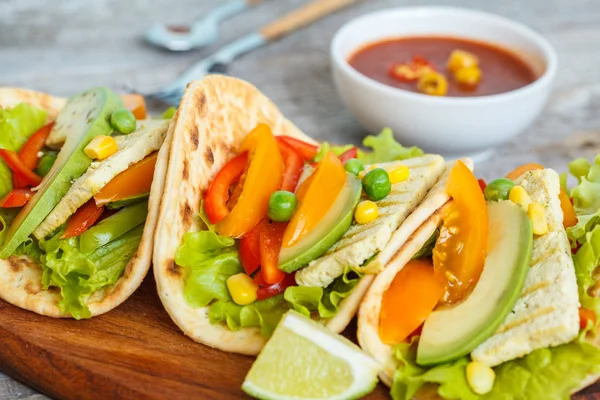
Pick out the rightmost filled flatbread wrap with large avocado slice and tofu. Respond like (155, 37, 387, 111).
(357, 160, 600, 400)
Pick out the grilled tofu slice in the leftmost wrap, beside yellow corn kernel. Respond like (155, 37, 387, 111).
(33, 120, 170, 240)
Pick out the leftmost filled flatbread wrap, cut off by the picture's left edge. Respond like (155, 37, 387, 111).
(0, 87, 169, 319)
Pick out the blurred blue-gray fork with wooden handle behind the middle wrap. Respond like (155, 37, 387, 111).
(144, 0, 359, 106)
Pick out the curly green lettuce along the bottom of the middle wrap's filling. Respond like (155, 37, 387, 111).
(175, 231, 359, 337)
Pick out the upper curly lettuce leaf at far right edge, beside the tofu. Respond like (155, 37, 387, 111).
(567, 155, 600, 244)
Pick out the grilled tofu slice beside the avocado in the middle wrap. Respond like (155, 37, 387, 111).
(296, 155, 445, 287)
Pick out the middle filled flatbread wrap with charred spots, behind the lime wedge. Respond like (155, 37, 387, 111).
(154, 76, 466, 354)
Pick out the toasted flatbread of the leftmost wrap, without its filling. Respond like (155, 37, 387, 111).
(0, 89, 168, 318)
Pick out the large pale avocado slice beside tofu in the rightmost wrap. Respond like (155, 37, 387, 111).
(417, 201, 533, 366)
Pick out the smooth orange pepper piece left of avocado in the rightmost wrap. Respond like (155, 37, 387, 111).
(379, 259, 444, 345)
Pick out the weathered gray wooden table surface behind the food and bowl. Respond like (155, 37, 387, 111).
(0, 0, 600, 399)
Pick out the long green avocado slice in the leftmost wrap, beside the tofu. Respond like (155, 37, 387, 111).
(0, 87, 123, 259)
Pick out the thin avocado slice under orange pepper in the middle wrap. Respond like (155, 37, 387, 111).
(278, 174, 362, 273)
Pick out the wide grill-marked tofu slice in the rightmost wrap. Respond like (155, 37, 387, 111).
(471, 169, 579, 366)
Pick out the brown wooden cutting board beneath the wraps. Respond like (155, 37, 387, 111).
(0, 277, 600, 400)
